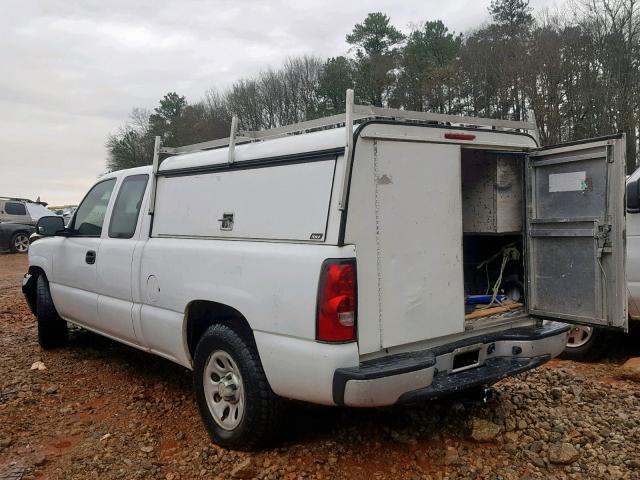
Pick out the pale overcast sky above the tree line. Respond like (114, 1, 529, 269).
(0, 0, 564, 205)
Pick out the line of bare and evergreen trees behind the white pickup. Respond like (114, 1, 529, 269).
(106, 0, 640, 172)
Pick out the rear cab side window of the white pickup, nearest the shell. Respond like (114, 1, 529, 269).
(109, 175, 149, 238)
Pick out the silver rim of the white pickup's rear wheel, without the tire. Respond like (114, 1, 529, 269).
(202, 350, 245, 430)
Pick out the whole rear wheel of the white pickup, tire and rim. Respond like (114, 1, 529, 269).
(193, 324, 281, 450)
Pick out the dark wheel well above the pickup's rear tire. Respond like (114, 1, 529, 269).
(186, 300, 255, 359)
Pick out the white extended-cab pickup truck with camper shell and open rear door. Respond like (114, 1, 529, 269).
(23, 95, 627, 449)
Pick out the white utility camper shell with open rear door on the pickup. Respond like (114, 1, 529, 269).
(152, 112, 626, 352)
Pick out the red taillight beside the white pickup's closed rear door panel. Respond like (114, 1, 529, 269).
(316, 260, 356, 342)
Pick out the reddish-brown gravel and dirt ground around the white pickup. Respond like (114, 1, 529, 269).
(0, 255, 640, 480)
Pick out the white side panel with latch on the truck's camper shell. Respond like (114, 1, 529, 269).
(153, 159, 335, 242)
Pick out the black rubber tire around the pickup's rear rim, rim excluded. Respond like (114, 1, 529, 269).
(193, 324, 282, 450)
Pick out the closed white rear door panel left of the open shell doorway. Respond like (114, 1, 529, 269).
(374, 141, 464, 348)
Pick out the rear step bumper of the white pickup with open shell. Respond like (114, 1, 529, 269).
(333, 322, 569, 407)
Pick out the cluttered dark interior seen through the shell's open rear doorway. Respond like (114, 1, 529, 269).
(461, 149, 525, 329)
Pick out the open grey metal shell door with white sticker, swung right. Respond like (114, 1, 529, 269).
(527, 135, 627, 329)
